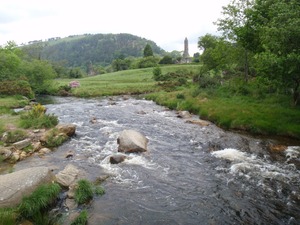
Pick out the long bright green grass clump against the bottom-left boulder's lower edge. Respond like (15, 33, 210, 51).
(18, 183, 61, 219)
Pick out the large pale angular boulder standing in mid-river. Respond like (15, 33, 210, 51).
(117, 130, 148, 153)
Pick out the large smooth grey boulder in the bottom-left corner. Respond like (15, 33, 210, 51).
(0, 167, 54, 208)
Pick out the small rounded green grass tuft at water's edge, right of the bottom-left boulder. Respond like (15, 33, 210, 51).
(74, 179, 94, 204)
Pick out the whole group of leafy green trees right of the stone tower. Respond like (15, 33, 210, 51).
(198, 0, 300, 105)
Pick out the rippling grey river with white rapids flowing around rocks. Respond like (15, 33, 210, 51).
(18, 97, 300, 225)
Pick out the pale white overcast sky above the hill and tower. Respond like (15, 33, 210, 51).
(0, 0, 230, 55)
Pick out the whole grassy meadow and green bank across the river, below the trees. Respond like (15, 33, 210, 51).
(52, 65, 300, 140)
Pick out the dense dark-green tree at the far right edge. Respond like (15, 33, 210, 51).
(251, 0, 300, 105)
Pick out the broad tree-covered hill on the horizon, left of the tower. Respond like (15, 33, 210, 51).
(24, 33, 165, 66)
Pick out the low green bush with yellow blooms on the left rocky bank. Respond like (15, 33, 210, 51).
(20, 104, 58, 128)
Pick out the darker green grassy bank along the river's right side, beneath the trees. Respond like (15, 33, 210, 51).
(146, 87, 300, 139)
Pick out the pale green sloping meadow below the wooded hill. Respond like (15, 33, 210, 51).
(57, 65, 199, 97)
